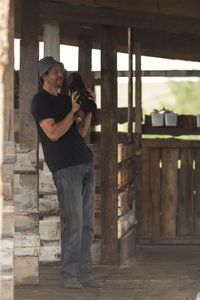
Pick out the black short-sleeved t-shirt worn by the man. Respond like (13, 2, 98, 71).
(31, 90, 92, 172)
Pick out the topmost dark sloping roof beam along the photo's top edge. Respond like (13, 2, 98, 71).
(40, 1, 200, 33)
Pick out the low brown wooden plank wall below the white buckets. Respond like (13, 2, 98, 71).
(139, 140, 200, 243)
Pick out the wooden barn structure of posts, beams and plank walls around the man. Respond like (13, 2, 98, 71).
(0, 0, 200, 300)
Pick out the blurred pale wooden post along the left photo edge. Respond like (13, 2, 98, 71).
(0, 0, 15, 300)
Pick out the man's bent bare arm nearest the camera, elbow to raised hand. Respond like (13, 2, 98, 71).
(40, 93, 80, 142)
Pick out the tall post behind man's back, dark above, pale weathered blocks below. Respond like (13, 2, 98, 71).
(14, 0, 40, 284)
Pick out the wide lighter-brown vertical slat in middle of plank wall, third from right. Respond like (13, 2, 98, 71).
(161, 148, 178, 238)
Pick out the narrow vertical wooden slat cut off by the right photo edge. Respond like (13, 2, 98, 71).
(193, 149, 200, 236)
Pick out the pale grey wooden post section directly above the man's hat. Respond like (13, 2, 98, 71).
(43, 21, 60, 61)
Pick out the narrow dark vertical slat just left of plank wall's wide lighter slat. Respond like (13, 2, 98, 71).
(149, 148, 161, 238)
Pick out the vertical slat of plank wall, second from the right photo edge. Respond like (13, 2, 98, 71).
(177, 149, 193, 236)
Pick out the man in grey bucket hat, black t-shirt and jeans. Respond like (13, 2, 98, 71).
(31, 56, 102, 288)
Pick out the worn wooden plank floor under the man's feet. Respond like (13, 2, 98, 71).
(15, 246, 200, 300)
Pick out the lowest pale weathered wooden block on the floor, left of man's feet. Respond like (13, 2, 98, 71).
(14, 256, 39, 285)
